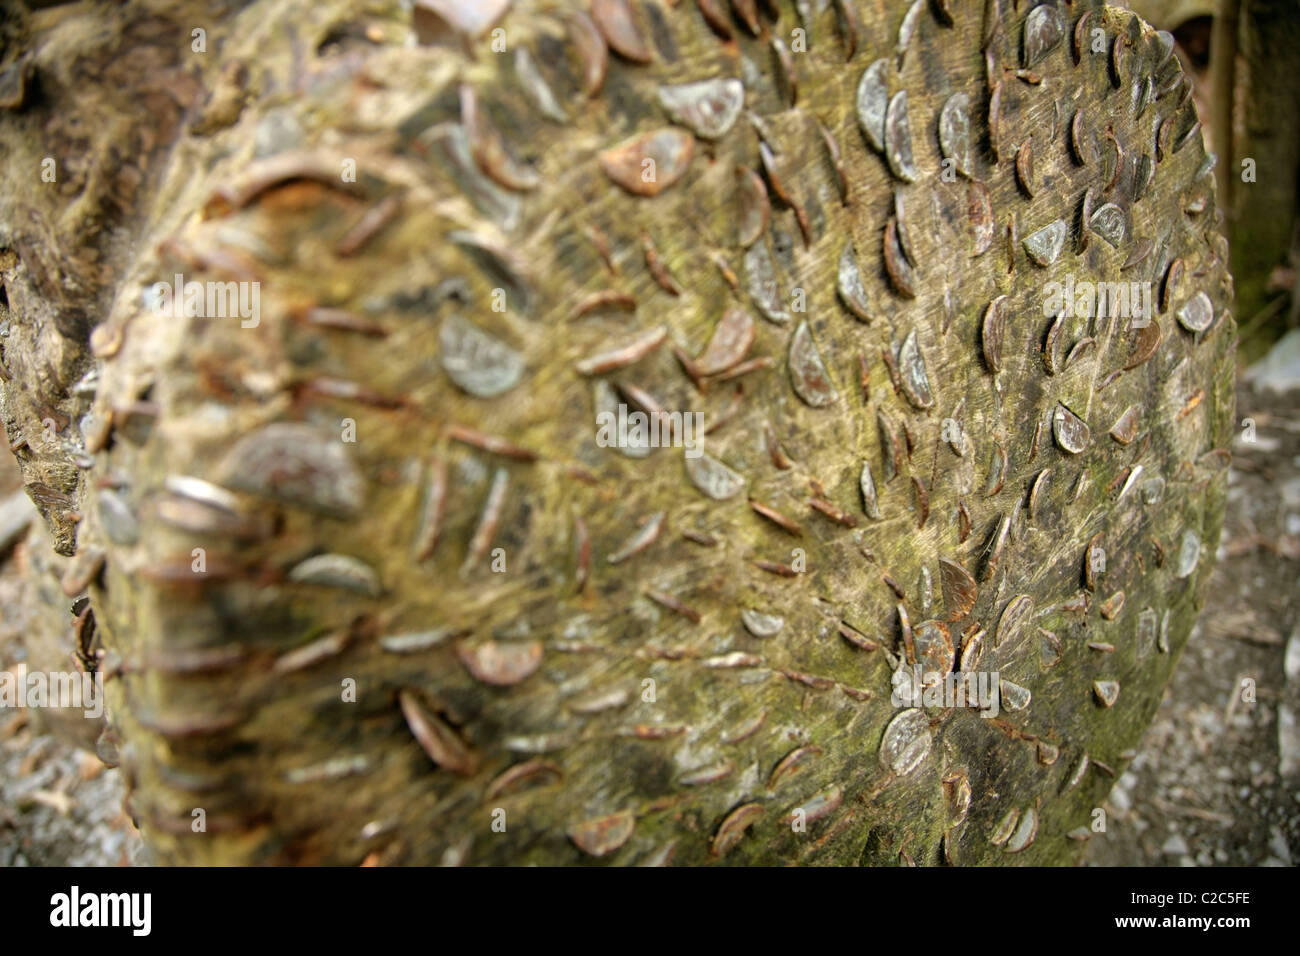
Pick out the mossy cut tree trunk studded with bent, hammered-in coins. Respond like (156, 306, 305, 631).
(0, 0, 1235, 864)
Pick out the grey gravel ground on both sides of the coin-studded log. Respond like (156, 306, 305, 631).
(0, 371, 1300, 866)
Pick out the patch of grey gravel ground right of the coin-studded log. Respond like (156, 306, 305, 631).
(1087, 371, 1300, 866)
